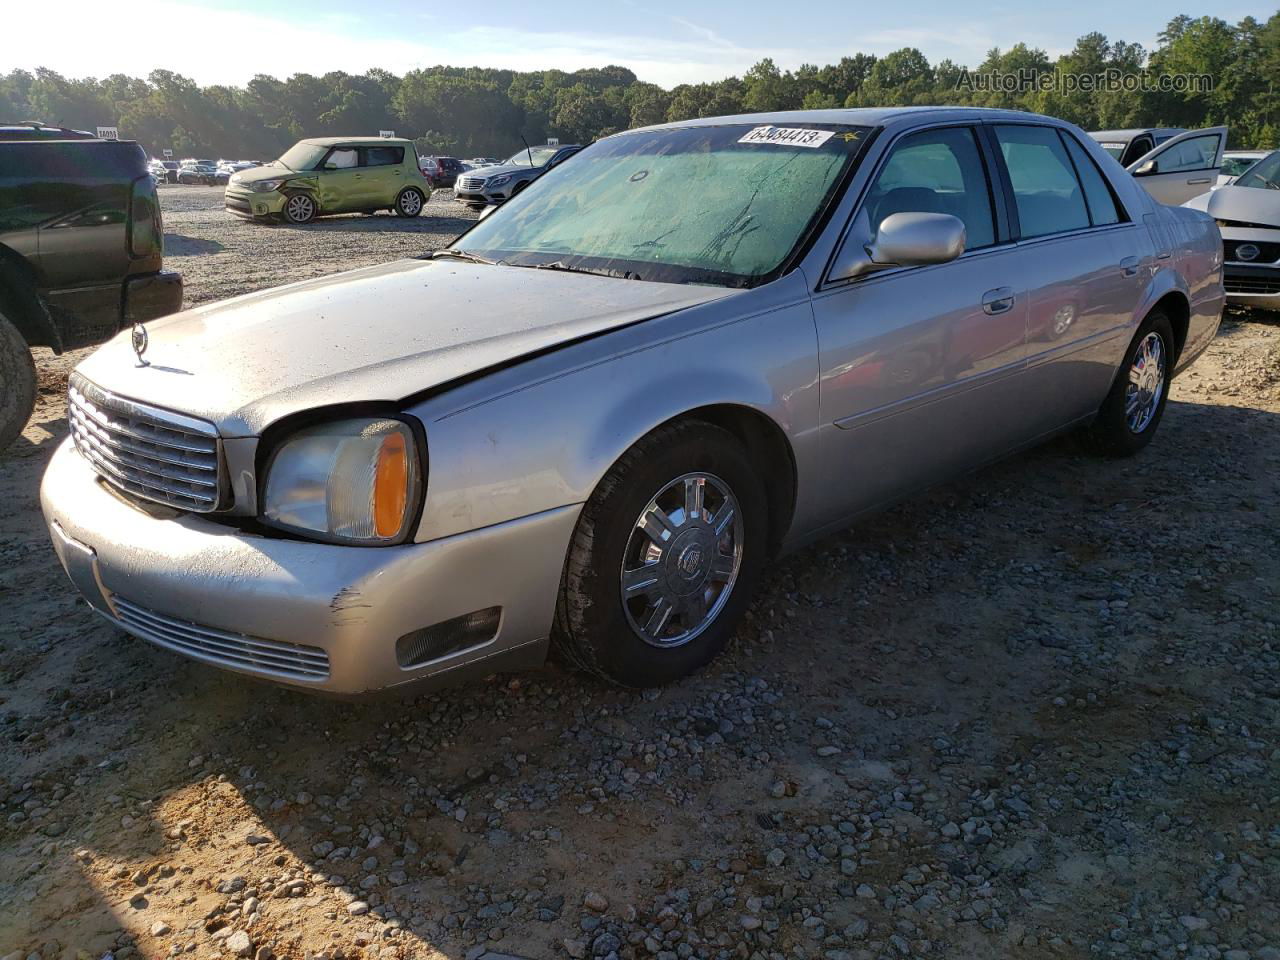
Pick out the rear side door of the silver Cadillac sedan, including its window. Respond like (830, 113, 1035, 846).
(991, 123, 1155, 435)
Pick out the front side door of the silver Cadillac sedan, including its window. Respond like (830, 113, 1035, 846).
(813, 124, 1027, 522)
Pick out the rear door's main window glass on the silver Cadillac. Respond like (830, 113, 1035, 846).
(996, 125, 1089, 237)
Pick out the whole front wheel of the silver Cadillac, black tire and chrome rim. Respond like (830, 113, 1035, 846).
(553, 420, 768, 687)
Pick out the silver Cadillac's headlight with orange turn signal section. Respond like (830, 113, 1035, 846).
(262, 419, 421, 544)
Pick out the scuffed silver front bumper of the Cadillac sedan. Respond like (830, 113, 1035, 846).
(40, 440, 580, 695)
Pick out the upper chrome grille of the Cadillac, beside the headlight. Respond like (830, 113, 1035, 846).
(67, 374, 221, 513)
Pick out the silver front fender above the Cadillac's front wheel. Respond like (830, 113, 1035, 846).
(410, 281, 818, 545)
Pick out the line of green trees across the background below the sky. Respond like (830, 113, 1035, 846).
(0, 13, 1280, 159)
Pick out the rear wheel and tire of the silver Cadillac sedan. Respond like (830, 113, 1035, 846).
(1088, 314, 1176, 457)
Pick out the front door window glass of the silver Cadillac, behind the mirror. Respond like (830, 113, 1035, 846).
(865, 127, 996, 250)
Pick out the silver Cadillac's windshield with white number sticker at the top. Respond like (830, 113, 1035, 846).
(456, 124, 869, 287)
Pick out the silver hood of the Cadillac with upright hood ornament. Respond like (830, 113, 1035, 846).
(78, 260, 739, 436)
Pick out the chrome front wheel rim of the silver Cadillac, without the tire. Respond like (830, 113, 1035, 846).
(621, 474, 744, 648)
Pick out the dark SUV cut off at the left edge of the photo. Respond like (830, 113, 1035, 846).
(0, 128, 182, 449)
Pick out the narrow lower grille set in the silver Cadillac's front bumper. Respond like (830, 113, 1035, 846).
(111, 594, 329, 681)
